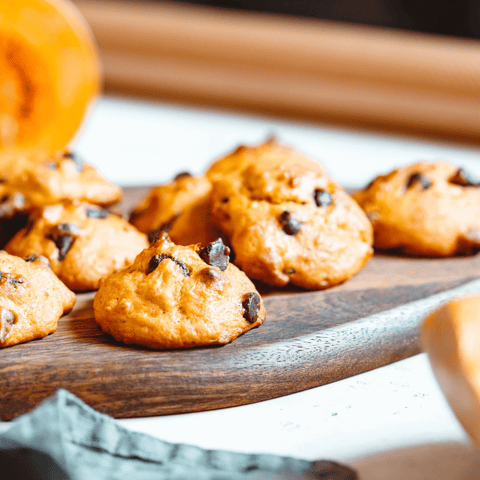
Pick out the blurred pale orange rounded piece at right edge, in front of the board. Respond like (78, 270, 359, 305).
(421, 295, 480, 446)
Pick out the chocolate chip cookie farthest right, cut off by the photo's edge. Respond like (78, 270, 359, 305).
(354, 161, 480, 257)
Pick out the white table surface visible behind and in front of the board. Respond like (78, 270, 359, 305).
(9, 98, 480, 480)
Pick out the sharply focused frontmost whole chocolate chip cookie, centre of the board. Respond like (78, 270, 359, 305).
(93, 232, 266, 349)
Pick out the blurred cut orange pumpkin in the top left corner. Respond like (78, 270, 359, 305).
(0, 0, 100, 151)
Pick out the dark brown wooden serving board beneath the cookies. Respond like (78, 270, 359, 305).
(0, 188, 480, 420)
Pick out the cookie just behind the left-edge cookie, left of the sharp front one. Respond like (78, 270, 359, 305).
(5, 202, 148, 291)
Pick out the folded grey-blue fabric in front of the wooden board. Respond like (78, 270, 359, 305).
(0, 390, 357, 480)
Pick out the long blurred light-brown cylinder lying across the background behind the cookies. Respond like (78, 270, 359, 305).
(75, 0, 480, 141)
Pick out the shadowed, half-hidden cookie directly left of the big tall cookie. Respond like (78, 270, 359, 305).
(130, 172, 221, 245)
